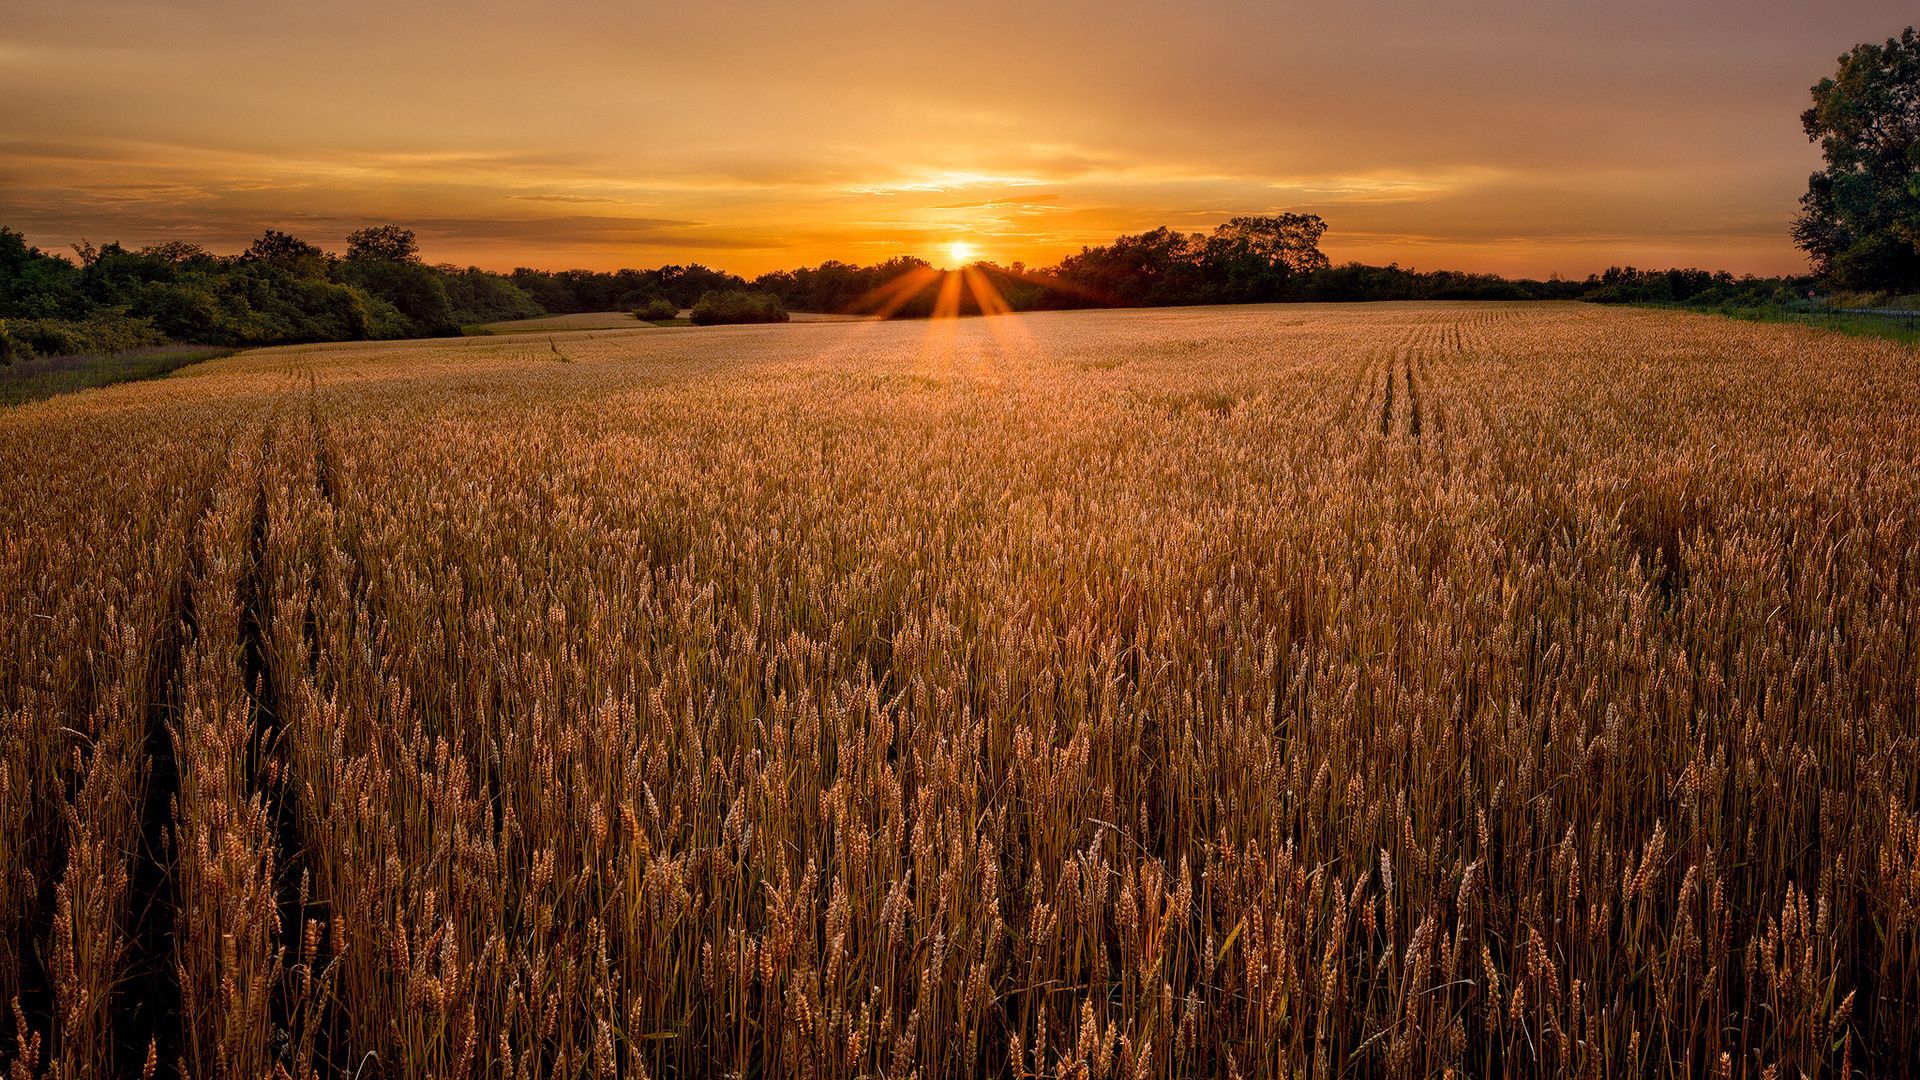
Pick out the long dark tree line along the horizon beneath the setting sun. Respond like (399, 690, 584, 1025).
(0, 213, 1805, 361)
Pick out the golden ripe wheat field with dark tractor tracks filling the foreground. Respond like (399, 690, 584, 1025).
(0, 304, 1920, 1078)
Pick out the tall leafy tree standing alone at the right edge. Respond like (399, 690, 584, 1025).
(1793, 27, 1920, 290)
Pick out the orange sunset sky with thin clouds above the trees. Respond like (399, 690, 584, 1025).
(0, 0, 1916, 277)
